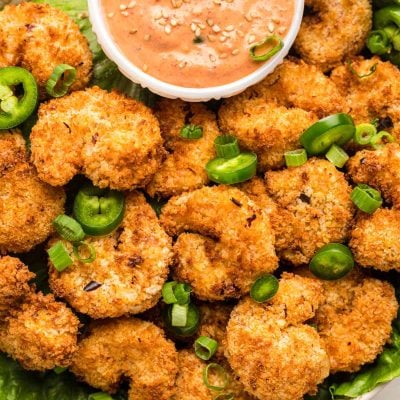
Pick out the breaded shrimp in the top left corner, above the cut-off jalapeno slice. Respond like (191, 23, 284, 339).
(0, 2, 92, 97)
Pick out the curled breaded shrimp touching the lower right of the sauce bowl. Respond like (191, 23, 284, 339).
(219, 60, 345, 171)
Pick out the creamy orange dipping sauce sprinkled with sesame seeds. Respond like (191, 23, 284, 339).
(101, 0, 295, 88)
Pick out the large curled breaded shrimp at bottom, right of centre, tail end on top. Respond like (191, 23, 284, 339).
(226, 273, 329, 400)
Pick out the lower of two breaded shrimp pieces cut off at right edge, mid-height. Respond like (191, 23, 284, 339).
(349, 208, 400, 271)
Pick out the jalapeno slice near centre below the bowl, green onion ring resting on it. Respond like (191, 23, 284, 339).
(206, 153, 257, 185)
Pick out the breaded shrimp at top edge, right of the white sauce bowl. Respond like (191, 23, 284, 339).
(294, 0, 372, 71)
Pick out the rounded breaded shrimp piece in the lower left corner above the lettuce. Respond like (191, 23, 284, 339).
(0, 293, 79, 371)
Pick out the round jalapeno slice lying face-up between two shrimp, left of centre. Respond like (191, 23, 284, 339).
(74, 185, 125, 236)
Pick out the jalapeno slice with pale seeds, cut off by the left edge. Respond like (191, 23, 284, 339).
(0, 67, 39, 129)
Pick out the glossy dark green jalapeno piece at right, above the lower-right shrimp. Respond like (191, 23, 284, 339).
(309, 243, 354, 281)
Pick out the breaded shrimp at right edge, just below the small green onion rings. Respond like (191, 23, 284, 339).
(347, 143, 400, 208)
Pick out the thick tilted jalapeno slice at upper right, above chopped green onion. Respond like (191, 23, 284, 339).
(300, 113, 356, 155)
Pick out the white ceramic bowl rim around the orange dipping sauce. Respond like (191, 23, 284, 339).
(88, 0, 304, 101)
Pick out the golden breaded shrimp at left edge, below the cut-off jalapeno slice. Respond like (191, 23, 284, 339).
(0, 131, 65, 254)
